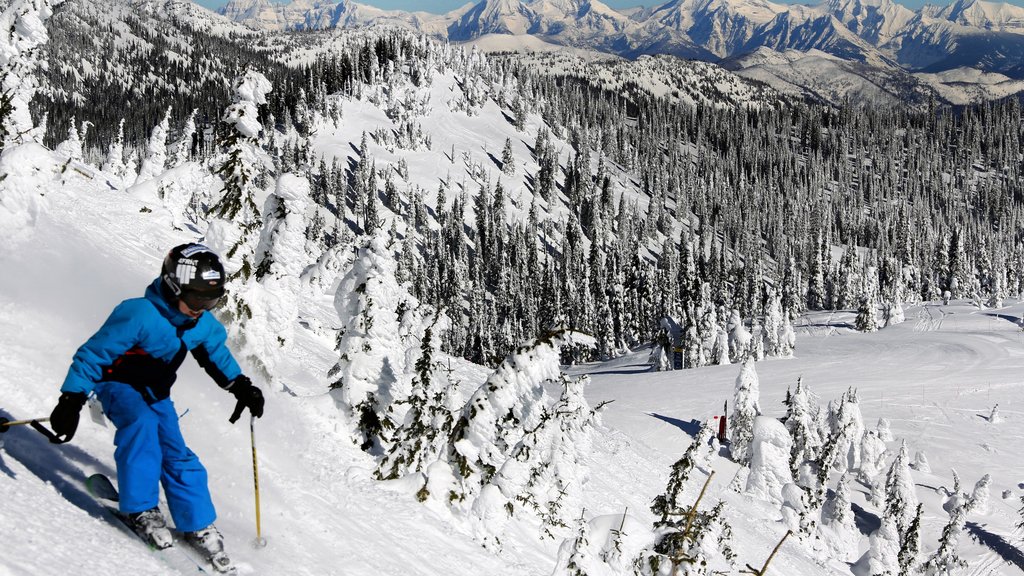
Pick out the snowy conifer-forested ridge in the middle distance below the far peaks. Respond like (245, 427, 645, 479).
(28, 2, 1024, 365)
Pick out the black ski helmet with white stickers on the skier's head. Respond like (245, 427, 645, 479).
(160, 243, 226, 311)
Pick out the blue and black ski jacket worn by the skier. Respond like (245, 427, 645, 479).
(60, 278, 242, 404)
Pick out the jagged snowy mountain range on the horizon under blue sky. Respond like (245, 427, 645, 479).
(220, 0, 1024, 80)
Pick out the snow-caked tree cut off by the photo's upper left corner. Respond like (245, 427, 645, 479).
(0, 0, 61, 153)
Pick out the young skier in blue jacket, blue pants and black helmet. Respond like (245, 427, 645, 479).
(50, 244, 263, 568)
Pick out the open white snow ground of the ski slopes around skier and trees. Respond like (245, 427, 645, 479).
(6, 157, 1024, 576)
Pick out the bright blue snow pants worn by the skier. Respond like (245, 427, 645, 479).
(95, 381, 217, 532)
